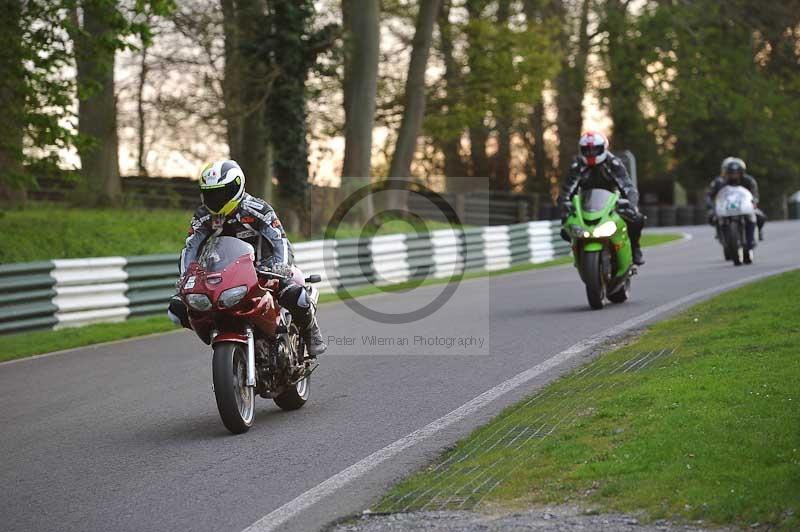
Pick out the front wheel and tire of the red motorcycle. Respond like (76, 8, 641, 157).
(211, 342, 255, 434)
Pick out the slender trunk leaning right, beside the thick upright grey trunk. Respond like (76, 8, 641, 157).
(389, 0, 440, 209)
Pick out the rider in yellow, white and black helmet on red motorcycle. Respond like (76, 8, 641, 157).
(169, 160, 328, 357)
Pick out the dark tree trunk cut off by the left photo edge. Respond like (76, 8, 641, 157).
(0, 0, 25, 201)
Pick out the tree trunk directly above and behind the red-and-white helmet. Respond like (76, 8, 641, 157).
(554, 0, 591, 179)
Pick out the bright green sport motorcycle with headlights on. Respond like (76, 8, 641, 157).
(563, 189, 636, 310)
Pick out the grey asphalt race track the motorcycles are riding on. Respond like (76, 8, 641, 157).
(0, 222, 800, 531)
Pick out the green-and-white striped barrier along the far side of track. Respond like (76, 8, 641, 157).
(0, 221, 569, 334)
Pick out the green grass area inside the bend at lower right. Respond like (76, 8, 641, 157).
(378, 271, 800, 530)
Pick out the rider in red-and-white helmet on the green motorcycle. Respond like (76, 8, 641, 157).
(559, 131, 644, 266)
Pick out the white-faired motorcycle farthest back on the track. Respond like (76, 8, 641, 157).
(714, 185, 756, 266)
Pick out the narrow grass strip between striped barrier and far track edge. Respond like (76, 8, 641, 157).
(0, 234, 681, 362)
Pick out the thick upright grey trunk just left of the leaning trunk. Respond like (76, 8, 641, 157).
(342, 0, 380, 222)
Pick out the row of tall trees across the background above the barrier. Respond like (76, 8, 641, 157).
(0, 0, 800, 218)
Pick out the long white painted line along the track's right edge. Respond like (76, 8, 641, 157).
(244, 267, 796, 532)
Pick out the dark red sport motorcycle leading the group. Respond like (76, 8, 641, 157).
(180, 236, 320, 434)
